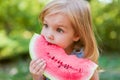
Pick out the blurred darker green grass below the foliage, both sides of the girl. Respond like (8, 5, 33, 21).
(0, 54, 120, 80)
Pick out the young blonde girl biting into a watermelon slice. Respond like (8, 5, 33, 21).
(30, 0, 99, 80)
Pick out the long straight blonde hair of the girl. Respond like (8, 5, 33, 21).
(39, 0, 99, 63)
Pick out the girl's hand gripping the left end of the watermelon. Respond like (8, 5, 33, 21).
(29, 59, 46, 80)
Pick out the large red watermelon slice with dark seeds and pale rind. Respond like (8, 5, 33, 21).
(29, 34, 97, 80)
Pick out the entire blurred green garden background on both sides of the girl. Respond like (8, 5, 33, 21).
(0, 0, 120, 80)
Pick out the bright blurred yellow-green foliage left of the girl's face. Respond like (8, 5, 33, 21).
(0, 0, 51, 60)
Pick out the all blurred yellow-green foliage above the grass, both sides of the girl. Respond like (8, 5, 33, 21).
(0, 0, 120, 60)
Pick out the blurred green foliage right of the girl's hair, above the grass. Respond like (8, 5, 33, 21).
(91, 0, 120, 53)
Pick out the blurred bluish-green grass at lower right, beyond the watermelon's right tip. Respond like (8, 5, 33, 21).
(99, 54, 120, 80)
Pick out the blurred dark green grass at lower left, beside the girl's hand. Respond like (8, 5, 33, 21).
(0, 55, 32, 80)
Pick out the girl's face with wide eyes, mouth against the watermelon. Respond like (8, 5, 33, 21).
(41, 13, 79, 52)
